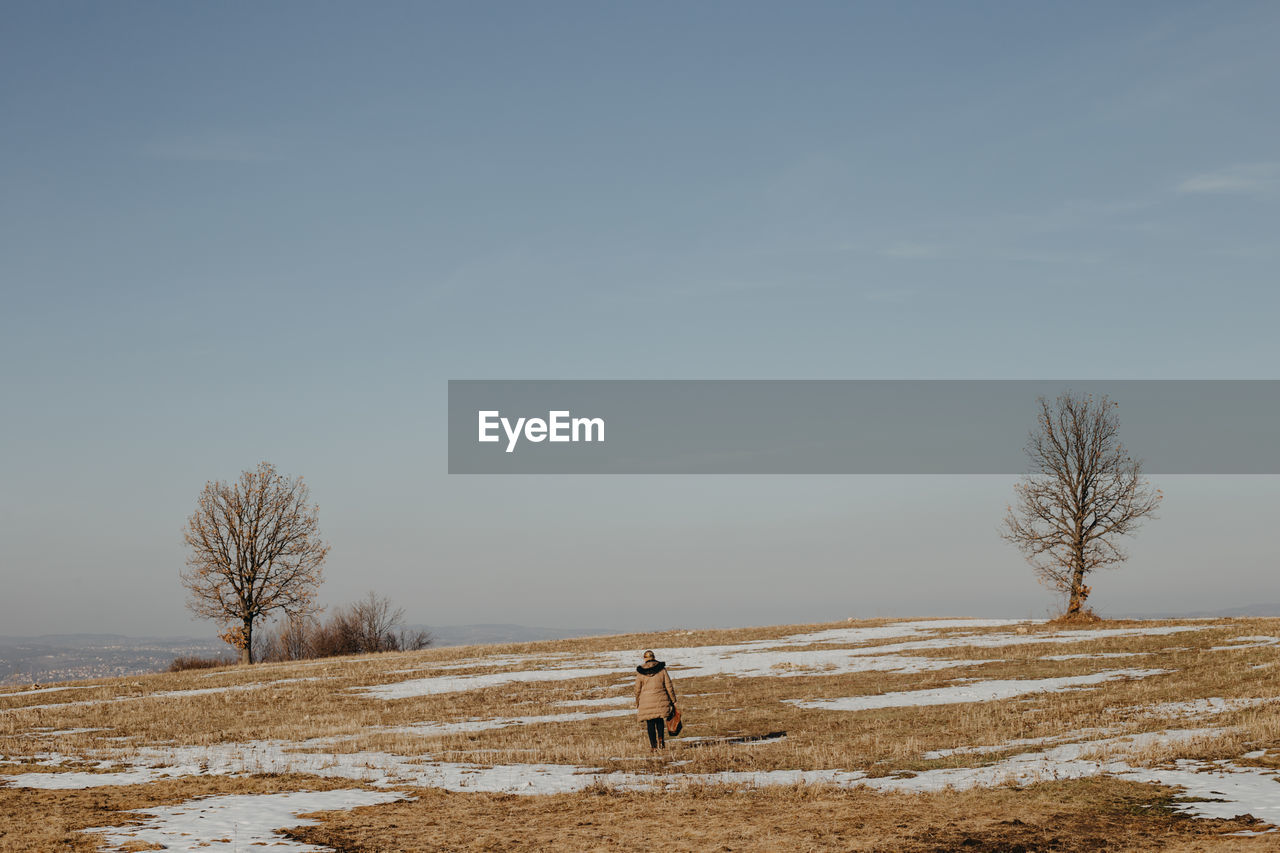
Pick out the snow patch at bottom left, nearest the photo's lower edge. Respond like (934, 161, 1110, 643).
(83, 789, 406, 853)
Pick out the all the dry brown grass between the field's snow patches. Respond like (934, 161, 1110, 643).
(0, 620, 1280, 850)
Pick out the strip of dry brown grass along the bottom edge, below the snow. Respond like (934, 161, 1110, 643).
(280, 780, 1267, 853)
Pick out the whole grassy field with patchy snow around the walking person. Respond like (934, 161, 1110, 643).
(0, 620, 1280, 853)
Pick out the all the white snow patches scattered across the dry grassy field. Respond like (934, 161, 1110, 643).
(0, 620, 1280, 829)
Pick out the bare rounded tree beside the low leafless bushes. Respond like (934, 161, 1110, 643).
(182, 462, 329, 663)
